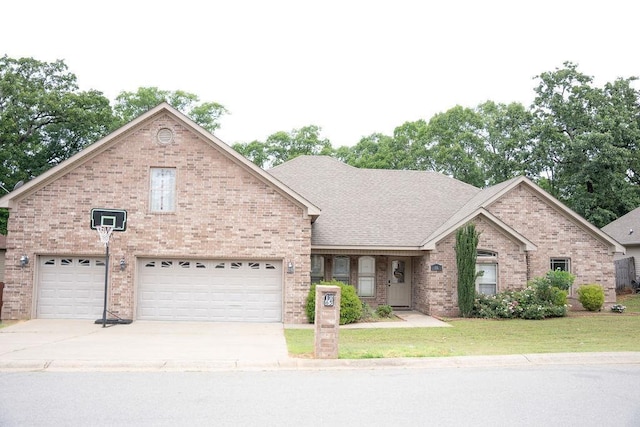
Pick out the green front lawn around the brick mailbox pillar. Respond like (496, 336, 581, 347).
(285, 295, 640, 359)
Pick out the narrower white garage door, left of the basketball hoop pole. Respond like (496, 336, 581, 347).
(36, 256, 104, 320)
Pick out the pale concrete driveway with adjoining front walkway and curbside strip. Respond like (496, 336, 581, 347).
(0, 312, 640, 372)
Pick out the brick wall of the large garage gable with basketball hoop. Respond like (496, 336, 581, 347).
(2, 115, 311, 323)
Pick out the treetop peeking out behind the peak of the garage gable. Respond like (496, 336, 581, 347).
(113, 87, 228, 133)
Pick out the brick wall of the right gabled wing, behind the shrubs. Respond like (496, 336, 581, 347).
(414, 185, 616, 316)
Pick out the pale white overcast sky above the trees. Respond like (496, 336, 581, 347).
(0, 0, 640, 147)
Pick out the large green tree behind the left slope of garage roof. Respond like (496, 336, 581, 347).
(0, 55, 114, 233)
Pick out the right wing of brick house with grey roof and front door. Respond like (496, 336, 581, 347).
(270, 156, 623, 315)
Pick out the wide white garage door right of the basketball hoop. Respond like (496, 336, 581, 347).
(137, 259, 282, 322)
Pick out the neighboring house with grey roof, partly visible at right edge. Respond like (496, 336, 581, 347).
(602, 207, 640, 286)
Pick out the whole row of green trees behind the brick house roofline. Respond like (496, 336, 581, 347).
(0, 56, 640, 231)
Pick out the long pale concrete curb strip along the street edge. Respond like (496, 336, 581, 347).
(0, 352, 640, 372)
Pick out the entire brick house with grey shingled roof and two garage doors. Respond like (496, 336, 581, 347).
(0, 104, 623, 323)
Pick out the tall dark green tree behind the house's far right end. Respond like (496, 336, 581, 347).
(531, 62, 640, 227)
